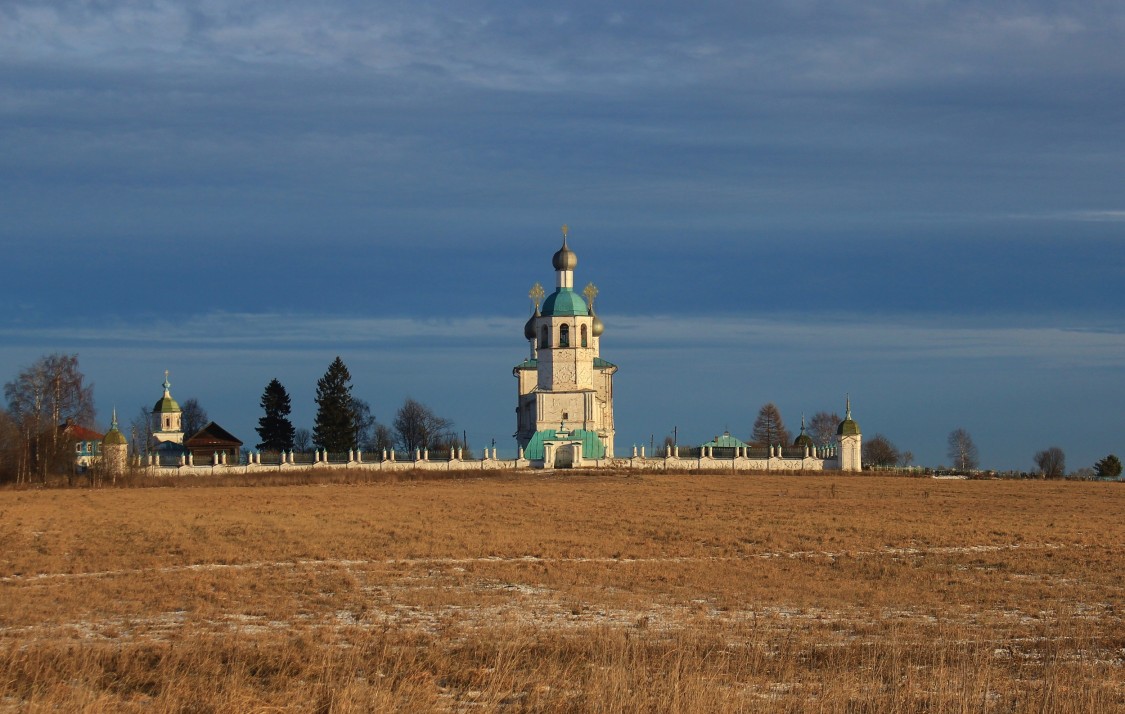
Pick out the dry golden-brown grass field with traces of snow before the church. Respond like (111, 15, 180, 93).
(0, 473, 1125, 713)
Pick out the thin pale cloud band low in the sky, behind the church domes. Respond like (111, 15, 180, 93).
(0, 313, 1125, 367)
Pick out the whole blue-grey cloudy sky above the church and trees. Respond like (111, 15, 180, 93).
(0, 0, 1125, 470)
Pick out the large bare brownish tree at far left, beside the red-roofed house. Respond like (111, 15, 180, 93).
(3, 354, 93, 481)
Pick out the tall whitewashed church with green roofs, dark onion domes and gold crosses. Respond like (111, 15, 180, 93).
(512, 226, 618, 468)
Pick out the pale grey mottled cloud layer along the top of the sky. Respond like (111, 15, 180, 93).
(0, 0, 1125, 93)
